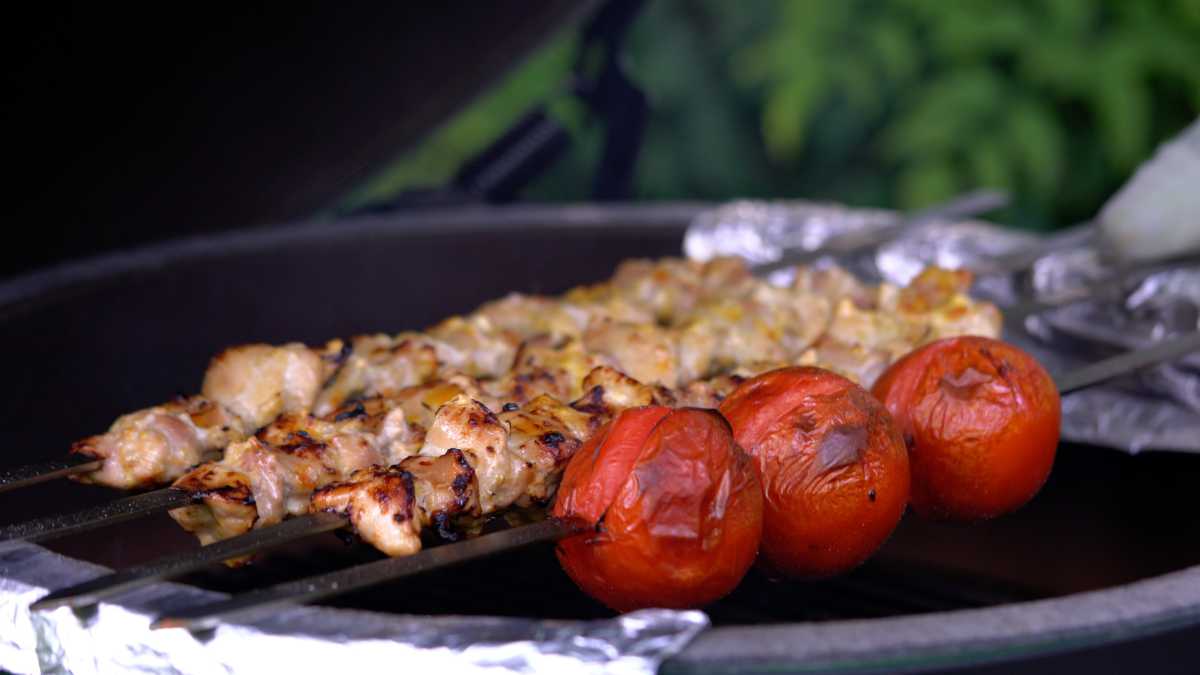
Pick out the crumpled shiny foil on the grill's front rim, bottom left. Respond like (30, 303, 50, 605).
(0, 543, 709, 675)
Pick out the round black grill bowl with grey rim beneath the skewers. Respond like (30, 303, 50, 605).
(0, 204, 1200, 673)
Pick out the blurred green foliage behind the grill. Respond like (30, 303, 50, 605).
(347, 0, 1200, 228)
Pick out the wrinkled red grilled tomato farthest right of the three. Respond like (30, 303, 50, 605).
(872, 338, 1062, 522)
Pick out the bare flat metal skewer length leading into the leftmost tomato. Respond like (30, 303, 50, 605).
(150, 519, 577, 631)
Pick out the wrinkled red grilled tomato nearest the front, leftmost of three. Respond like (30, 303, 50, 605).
(552, 407, 762, 611)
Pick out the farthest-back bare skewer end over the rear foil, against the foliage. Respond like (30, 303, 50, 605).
(750, 190, 1009, 276)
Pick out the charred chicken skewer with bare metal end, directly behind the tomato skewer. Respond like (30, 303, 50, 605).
(28, 366, 670, 609)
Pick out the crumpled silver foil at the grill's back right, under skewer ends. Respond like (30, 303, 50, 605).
(684, 202, 1200, 453)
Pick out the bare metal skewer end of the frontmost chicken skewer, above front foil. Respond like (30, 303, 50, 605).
(29, 512, 347, 611)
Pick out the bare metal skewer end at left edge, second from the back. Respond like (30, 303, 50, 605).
(0, 488, 200, 542)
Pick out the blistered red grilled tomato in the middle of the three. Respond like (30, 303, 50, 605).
(721, 368, 910, 579)
